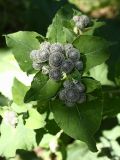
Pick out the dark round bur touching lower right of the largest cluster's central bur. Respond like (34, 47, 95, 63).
(61, 59, 74, 73)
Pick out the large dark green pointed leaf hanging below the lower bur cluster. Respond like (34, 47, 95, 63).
(51, 99, 102, 152)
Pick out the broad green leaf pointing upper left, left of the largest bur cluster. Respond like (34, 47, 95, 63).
(5, 31, 39, 73)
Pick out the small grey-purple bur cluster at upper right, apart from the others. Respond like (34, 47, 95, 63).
(73, 15, 90, 30)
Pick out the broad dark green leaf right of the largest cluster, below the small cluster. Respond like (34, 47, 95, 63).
(73, 35, 110, 71)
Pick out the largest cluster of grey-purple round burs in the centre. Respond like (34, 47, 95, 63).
(30, 41, 83, 81)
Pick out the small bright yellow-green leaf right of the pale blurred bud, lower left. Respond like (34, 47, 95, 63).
(25, 108, 46, 129)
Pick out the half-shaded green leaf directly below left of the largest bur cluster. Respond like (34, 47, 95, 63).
(24, 73, 61, 102)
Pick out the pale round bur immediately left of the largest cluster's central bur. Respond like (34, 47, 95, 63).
(39, 49, 49, 63)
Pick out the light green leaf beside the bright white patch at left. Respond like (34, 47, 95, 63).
(12, 78, 29, 105)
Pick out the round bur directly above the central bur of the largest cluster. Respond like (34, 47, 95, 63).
(50, 43, 63, 53)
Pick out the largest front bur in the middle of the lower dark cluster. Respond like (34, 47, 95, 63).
(65, 88, 80, 103)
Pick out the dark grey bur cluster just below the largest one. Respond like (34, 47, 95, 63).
(59, 80, 86, 107)
